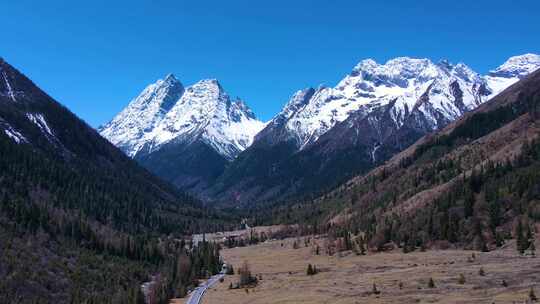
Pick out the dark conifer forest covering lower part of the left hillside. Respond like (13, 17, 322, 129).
(0, 129, 230, 304)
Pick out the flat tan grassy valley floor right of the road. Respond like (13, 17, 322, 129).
(187, 239, 540, 304)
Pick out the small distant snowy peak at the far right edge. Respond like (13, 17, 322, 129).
(490, 53, 540, 79)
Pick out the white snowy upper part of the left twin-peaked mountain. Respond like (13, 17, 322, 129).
(100, 76, 264, 159)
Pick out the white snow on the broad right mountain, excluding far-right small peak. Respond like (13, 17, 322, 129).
(274, 57, 490, 149)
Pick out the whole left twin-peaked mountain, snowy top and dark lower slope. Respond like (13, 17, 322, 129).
(99, 75, 264, 194)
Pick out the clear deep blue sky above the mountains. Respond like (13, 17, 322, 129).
(0, 0, 540, 127)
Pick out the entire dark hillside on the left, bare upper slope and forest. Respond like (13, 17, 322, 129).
(0, 60, 230, 303)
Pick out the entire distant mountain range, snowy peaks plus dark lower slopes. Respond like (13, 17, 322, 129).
(99, 54, 540, 205)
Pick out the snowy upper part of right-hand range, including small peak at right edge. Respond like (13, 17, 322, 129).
(269, 54, 540, 149)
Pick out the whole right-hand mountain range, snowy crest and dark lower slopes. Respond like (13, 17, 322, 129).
(213, 54, 540, 202)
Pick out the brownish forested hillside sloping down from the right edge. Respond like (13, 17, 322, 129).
(256, 71, 540, 251)
